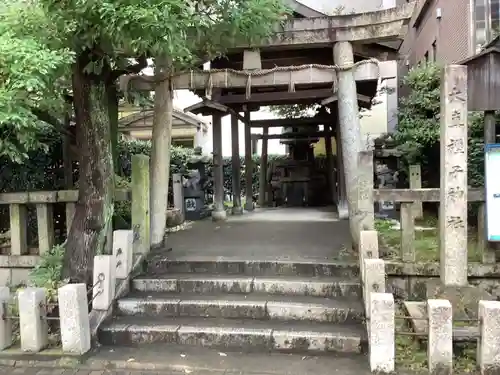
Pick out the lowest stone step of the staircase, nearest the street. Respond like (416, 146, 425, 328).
(98, 317, 366, 354)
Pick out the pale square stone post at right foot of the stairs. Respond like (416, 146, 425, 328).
(368, 293, 396, 373)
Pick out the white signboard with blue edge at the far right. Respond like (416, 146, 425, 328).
(484, 143, 500, 242)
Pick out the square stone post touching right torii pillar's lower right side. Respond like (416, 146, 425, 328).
(356, 151, 375, 235)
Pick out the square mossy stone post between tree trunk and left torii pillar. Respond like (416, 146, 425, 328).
(132, 155, 151, 254)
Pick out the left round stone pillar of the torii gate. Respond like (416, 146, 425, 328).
(150, 59, 173, 247)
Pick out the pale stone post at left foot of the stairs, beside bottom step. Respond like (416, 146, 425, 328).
(57, 284, 91, 354)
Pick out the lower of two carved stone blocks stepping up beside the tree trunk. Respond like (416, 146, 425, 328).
(92, 255, 116, 311)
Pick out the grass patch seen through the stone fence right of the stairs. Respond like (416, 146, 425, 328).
(375, 218, 482, 262)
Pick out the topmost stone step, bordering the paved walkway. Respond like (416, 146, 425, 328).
(147, 253, 359, 278)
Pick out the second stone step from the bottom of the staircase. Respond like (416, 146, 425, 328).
(116, 293, 364, 323)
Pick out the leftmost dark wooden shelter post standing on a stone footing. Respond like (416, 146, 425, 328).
(212, 113, 226, 221)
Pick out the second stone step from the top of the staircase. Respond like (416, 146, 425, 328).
(132, 273, 361, 298)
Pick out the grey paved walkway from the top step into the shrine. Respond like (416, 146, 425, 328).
(159, 207, 351, 261)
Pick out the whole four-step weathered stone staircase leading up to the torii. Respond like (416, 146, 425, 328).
(99, 256, 366, 354)
